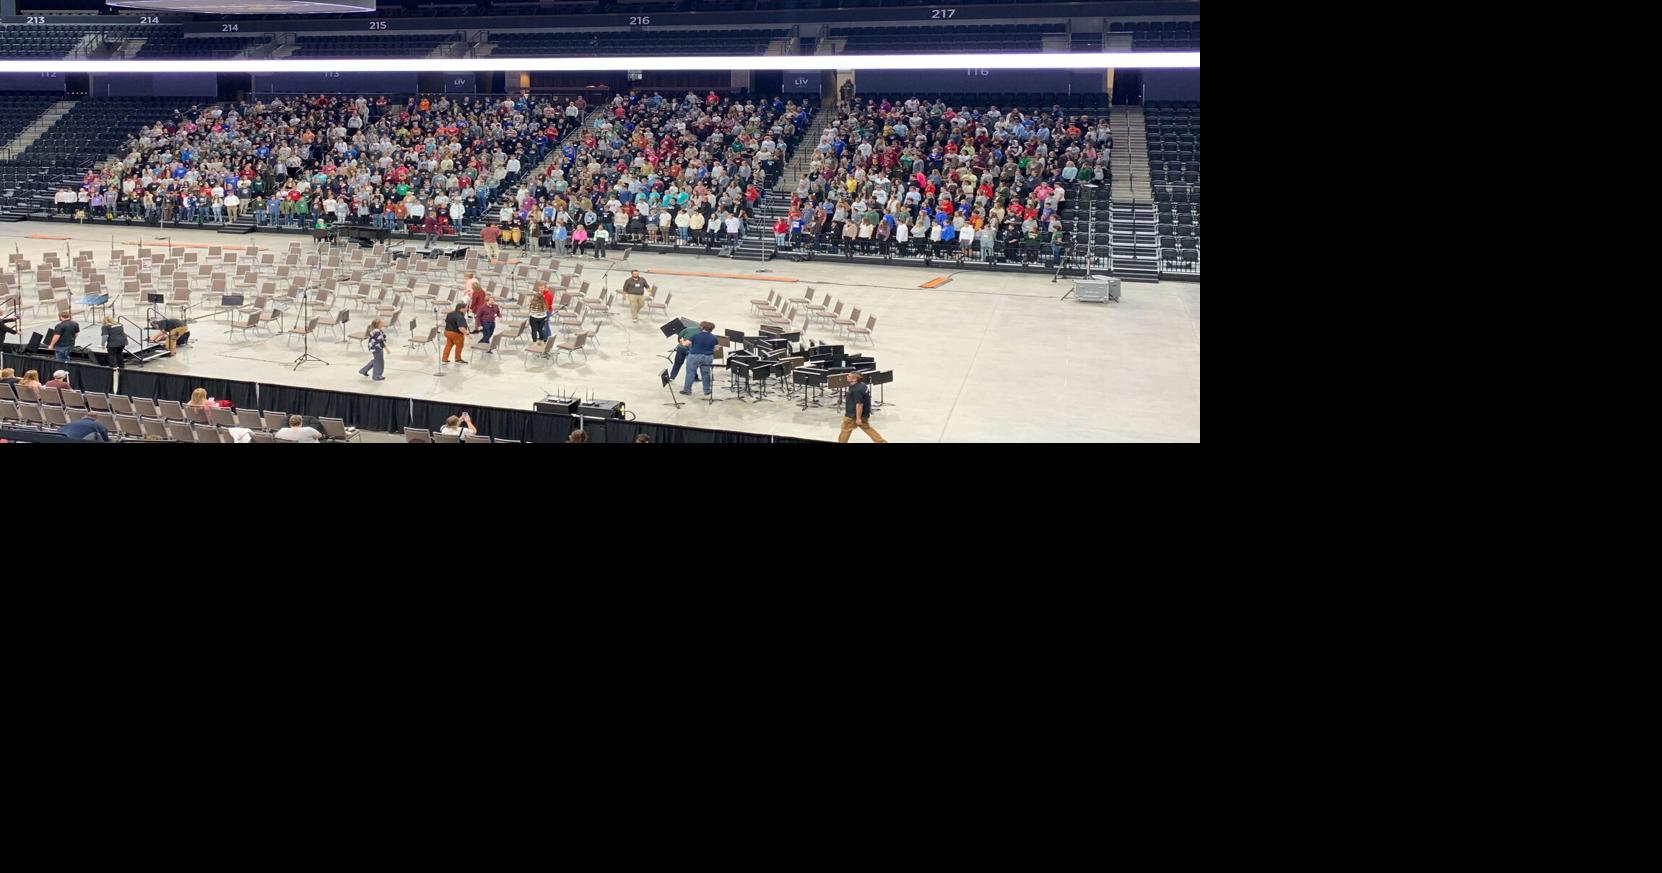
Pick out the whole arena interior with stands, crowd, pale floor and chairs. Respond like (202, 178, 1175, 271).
(0, 0, 1202, 444)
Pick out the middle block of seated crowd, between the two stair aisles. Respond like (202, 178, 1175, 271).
(484, 91, 811, 256)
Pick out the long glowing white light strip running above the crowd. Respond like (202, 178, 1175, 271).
(0, 52, 1200, 73)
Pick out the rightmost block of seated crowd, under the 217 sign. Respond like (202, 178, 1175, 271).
(773, 98, 1114, 261)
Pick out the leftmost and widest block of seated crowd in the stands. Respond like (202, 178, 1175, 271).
(57, 95, 588, 234)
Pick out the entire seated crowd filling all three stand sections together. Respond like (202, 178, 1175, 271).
(60, 93, 1112, 261)
